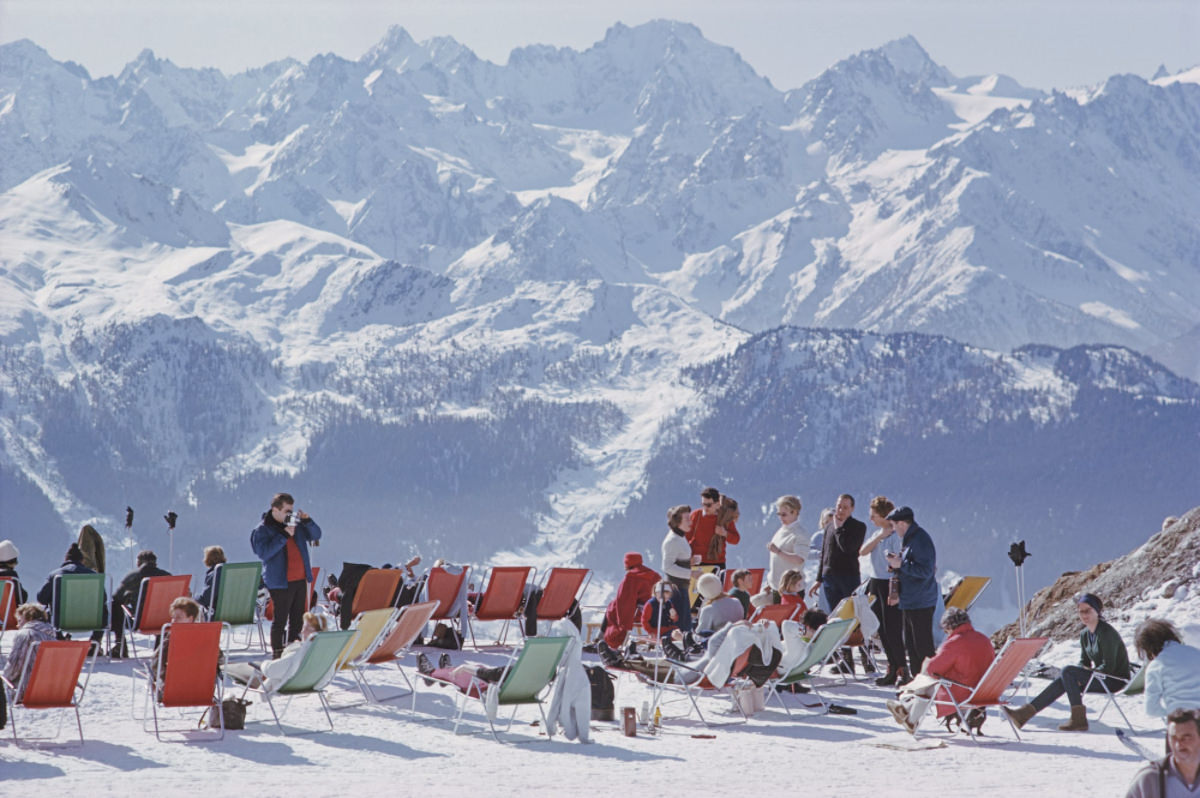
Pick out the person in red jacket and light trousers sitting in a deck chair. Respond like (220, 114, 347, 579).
(888, 607, 996, 734)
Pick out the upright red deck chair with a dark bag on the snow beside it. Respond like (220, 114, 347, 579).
(143, 622, 224, 740)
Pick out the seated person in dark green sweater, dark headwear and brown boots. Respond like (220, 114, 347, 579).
(1001, 593, 1129, 732)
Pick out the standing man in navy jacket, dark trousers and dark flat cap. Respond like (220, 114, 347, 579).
(887, 506, 937, 676)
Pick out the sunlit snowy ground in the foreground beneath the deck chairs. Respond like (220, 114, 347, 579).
(0, 619, 1162, 798)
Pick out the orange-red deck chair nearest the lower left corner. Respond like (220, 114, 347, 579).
(4, 640, 96, 745)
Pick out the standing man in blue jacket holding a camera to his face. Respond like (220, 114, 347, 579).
(250, 493, 320, 659)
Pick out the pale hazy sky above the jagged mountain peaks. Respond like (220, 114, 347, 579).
(0, 0, 1200, 89)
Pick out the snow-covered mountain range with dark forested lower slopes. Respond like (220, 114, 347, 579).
(0, 22, 1200, 600)
